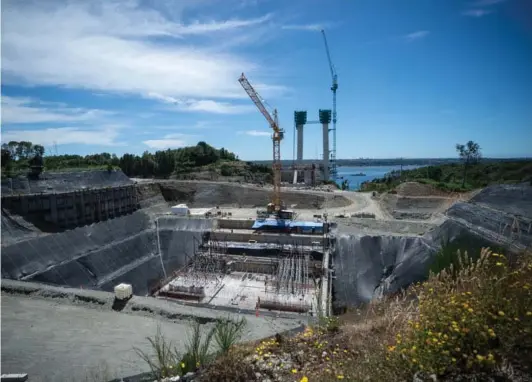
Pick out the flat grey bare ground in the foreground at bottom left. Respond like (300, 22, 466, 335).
(2, 280, 305, 382)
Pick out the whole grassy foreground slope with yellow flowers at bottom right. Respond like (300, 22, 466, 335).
(176, 246, 532, 382)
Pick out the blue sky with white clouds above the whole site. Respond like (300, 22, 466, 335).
(2, 0, 532, 160)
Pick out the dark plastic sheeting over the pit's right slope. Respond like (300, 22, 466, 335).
(333, 184, 532, 307)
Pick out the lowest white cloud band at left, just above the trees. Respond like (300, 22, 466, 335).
(2, 125, 123, 146)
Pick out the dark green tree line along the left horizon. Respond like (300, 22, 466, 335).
(2, 141, 271, 178)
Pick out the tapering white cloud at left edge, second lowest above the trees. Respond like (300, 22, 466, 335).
(2, 96, 110, 124)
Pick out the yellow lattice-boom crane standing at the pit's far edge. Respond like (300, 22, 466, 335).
(238, 73, 291, 219)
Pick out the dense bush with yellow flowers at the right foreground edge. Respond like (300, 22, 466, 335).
(387, 249, 532, 375)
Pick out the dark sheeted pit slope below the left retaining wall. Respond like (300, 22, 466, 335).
(2, 211, 212, 295)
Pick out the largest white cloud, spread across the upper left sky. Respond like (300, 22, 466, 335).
(2, 0, 282, 103)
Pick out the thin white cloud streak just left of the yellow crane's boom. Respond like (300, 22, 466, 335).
(148, 92, 254, 114)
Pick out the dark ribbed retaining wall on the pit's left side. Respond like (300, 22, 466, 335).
(2, 185, 138, 228)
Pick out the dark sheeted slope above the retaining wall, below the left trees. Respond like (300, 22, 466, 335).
(2, 170, 134, 195)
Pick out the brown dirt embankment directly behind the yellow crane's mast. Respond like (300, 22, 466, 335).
(154, 181, 352, 209)
